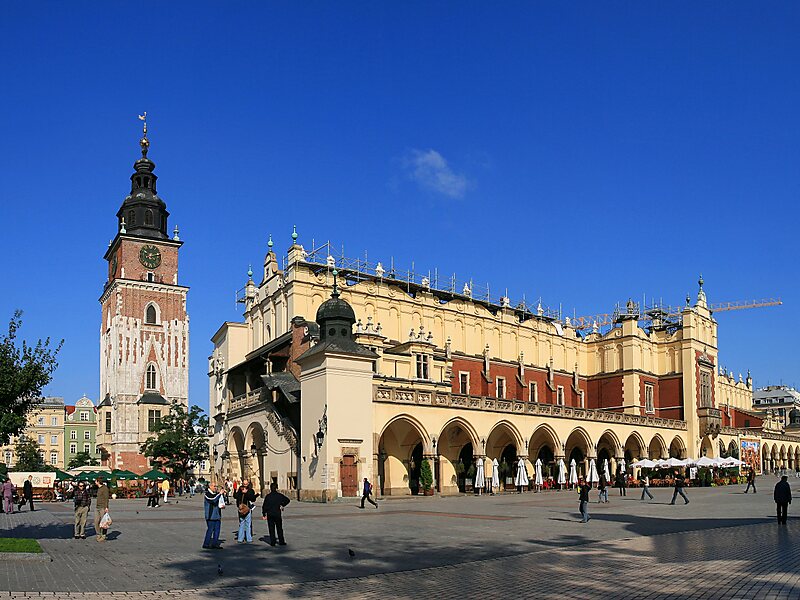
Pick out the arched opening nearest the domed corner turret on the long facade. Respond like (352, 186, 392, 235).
(378, 416, 428, 496)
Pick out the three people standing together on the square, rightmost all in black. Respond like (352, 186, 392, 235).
(203, 479, 290, 550)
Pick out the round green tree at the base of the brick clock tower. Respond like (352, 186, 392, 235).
(141, 403, 208, 477)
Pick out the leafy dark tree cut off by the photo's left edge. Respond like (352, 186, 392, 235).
(0, 310, 64, 446)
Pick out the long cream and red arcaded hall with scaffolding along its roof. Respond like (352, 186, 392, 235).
(209, 233, 800, 501)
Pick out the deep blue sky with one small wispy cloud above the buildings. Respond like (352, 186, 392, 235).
(0, 2, 800, 407)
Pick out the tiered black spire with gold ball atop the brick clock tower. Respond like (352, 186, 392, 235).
(117, 113, 169, 240)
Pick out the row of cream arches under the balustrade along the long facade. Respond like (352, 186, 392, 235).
(374, 405, 687, 495)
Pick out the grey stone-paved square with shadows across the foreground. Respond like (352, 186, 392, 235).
(0, 477, 800, 600)
